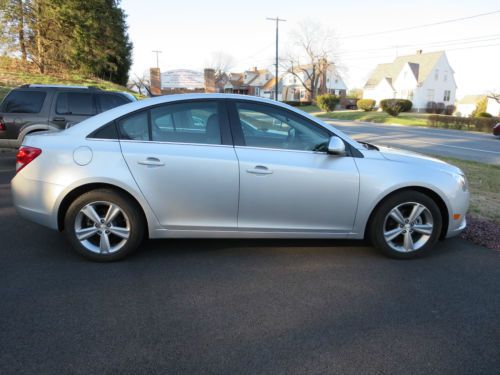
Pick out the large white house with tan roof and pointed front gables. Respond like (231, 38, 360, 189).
(363, 50, 457, 112)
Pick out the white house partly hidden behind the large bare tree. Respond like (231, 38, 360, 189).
(281, 64, 347, 102)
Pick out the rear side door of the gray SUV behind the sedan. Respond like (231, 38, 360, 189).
(49, 90, 97, 129)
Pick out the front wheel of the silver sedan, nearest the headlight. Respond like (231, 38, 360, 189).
(369, 190, 443, 259)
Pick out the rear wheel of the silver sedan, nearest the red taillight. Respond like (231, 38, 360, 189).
(64, 189, 145, 262)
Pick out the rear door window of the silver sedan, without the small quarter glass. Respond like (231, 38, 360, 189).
(151, 102, 221, 145)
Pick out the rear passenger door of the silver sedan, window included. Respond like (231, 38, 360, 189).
(117, 100, 239, 230)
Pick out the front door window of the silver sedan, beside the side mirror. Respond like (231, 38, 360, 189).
(236, 103, 330, 151)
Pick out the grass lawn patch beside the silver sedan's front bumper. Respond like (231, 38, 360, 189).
(434, 155, 500, 225)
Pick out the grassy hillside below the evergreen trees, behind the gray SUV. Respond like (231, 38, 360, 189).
(0, 57, 140, 101)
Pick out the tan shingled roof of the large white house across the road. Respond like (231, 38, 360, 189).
(365, 51, 444, 88)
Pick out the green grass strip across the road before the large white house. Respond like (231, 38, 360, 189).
(317, 111, 427, 126)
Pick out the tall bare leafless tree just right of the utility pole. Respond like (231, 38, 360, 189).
(282, 21, 335, 100)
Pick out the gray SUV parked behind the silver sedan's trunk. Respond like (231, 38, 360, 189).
(0, 85, 137, 147)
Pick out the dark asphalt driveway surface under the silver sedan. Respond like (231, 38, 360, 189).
(0, 153, 500, 374)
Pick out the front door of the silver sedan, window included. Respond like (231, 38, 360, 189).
(230, 101, 359, 233)
